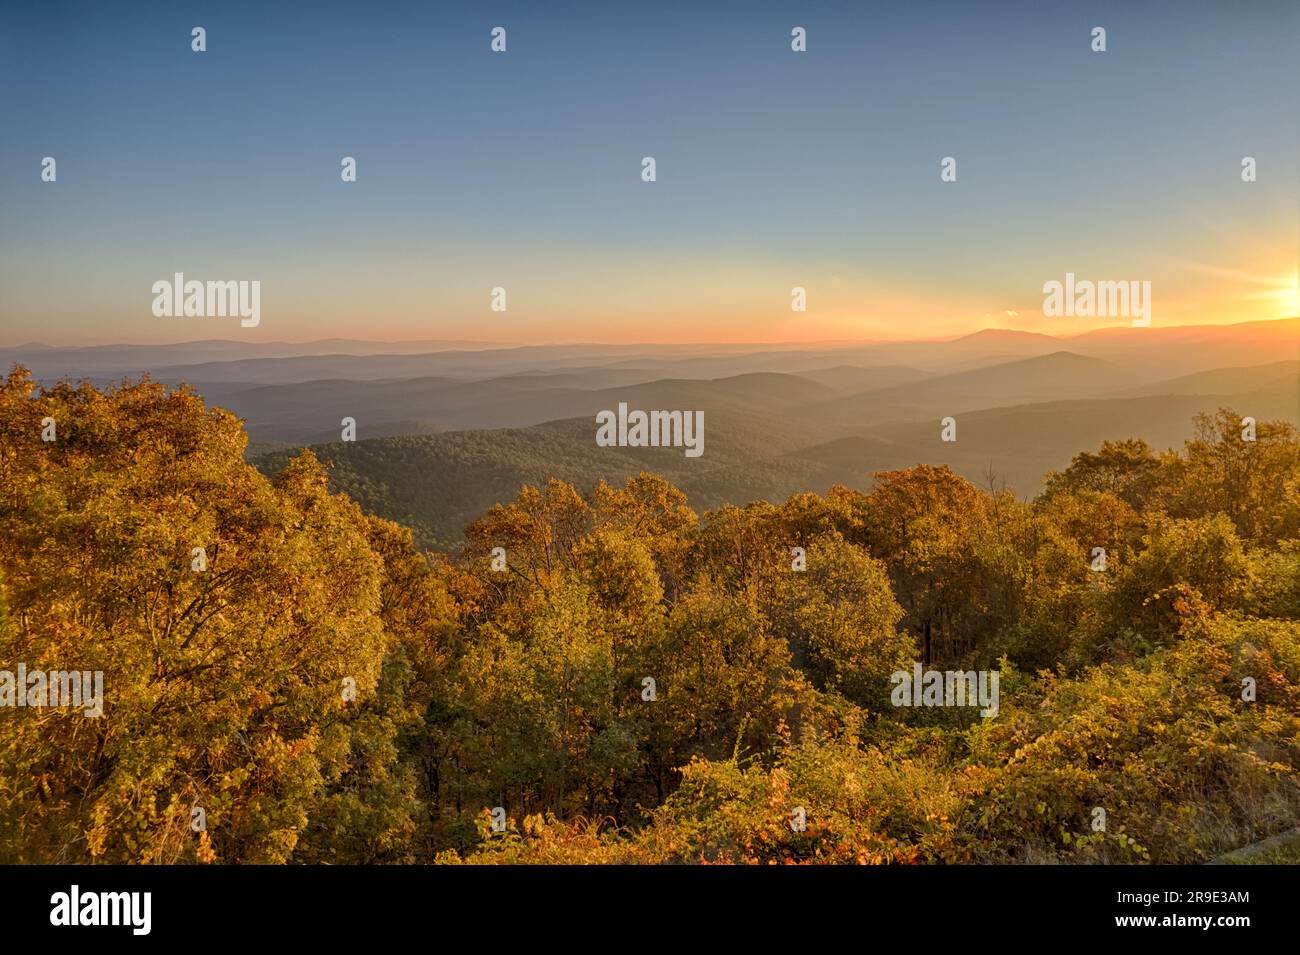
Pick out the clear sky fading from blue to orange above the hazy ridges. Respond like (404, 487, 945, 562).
(0, 0, 1300, 344)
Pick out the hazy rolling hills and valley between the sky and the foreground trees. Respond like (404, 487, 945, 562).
(0, 318, 1300, 548)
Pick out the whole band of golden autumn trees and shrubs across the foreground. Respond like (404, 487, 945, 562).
(0, 369, 1300, 863)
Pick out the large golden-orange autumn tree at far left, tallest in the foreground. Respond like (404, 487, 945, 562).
(0, 374, 405, 861)
